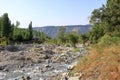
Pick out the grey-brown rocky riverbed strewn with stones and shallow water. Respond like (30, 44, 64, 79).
(0, 44, 87, 80)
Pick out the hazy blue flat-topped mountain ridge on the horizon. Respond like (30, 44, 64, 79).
(33, 25, 92, 37)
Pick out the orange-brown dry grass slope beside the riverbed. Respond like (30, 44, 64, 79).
(72, 46, 120, 80)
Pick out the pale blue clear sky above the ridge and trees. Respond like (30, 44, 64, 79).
(0, 0, 106, 28)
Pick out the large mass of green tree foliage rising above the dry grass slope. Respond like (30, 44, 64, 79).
(89, 0, 120, 42)
